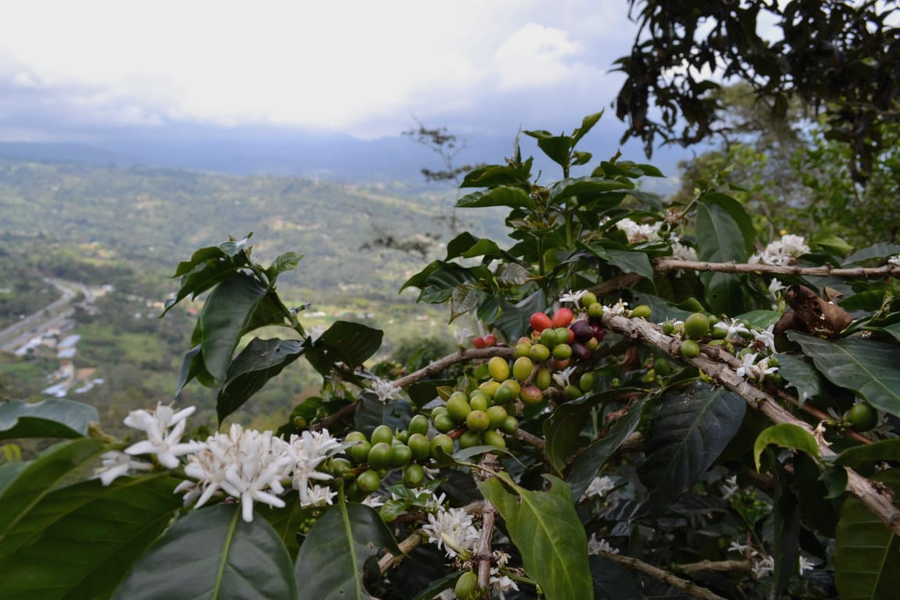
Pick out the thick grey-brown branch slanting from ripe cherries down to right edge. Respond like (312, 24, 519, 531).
(603, 315, 900, 534)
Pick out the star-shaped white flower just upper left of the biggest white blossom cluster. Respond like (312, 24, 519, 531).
(124, 404, 203, 469)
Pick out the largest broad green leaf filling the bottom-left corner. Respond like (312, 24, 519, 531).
(0, 475, 182, 600)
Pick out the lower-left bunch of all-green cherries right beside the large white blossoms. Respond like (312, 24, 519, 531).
(340, 415, 442, 500)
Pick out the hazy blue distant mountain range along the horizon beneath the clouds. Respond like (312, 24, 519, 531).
(0, 124, 685, 193)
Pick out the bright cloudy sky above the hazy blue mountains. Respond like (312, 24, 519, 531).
(0, 0, 635, 140)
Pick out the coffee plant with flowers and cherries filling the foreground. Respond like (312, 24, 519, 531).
(0, 114, 900, 600)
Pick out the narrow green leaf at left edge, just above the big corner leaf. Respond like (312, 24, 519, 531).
(0, 438, 107, 559)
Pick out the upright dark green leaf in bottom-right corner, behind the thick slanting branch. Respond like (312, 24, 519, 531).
(834, 470, 900, 600)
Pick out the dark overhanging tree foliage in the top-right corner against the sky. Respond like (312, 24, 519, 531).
(616, 0, 900, 182)
